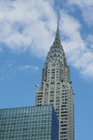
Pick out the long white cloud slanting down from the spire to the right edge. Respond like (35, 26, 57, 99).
(60, 11, 93, 77)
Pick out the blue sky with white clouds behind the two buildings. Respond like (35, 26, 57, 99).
(0, 0, 93, 140)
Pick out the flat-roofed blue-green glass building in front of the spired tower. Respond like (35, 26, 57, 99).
(0, 105, 59, 140)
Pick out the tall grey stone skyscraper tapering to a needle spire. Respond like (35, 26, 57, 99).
(35, 18, 74, 140)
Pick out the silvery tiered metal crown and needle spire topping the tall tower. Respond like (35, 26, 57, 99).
(42, 19, 69, 81)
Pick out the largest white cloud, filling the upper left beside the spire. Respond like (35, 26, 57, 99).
(0, 0, 56, 56)
